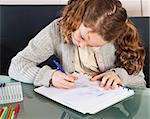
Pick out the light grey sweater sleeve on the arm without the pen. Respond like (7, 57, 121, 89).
(111, 68, 146, 88)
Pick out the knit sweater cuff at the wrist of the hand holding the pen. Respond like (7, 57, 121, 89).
(34, 65, 57, 87)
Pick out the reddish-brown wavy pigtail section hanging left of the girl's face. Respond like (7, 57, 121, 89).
(59, 0, 88, 43)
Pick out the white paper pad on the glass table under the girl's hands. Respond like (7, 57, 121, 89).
(34, 72, 134, 114)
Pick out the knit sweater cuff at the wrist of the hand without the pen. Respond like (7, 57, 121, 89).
(111, 68, 130, 85)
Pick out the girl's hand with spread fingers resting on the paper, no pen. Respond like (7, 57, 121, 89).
(91, 70, 123, 90)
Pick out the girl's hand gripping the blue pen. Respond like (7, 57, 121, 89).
(52, 71, 78, 89)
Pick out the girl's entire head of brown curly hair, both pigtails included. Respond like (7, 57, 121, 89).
(59, 0, 145, 74)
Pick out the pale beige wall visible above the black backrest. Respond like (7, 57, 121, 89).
(0, 0, 150, 16)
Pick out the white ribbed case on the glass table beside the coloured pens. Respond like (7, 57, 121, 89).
(0, 82, 23, 104)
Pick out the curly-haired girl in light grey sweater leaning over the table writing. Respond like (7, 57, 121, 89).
(9, 0, 145, 89)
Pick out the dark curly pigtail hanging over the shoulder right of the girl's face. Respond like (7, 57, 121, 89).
(115, 20, 145, 74)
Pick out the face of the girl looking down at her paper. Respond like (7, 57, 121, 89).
(72, 24, 107, 48)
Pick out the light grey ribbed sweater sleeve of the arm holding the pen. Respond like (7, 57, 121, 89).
(8, 20, 58, 86)
